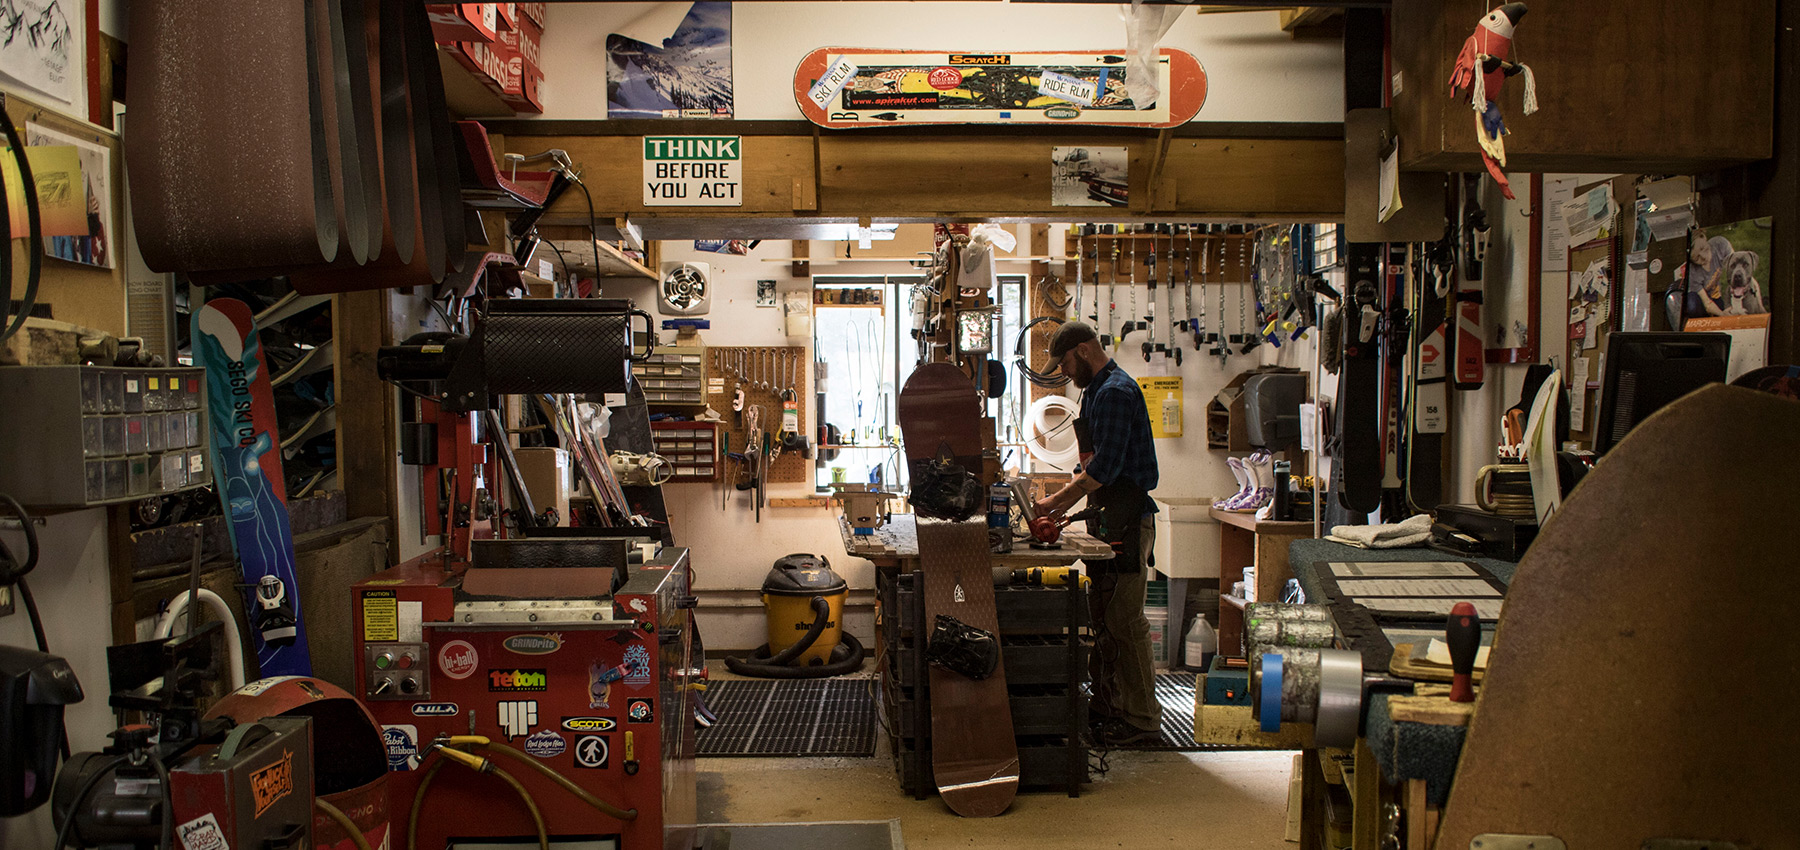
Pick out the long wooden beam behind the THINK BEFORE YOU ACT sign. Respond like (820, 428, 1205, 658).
(508, 126, 1345, 225)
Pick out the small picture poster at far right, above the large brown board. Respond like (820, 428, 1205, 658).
(1676, 218, 1773, 319)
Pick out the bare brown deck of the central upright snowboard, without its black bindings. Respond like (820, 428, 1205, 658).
(898, 364, 1019, 818)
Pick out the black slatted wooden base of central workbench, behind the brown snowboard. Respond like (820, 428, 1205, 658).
(875, 567, 1089, 800)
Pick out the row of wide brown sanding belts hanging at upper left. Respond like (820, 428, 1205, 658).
(124, 0, 464, 292)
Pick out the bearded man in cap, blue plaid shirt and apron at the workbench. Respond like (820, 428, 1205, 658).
(1037, 322, 1163, 746)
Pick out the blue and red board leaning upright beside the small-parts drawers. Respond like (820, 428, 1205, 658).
(193, 299, 313, 677)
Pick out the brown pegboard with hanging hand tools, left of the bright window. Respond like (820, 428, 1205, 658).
(706, 346, 814, 484)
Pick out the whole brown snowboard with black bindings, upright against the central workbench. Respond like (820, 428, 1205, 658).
(896, 364, 1019, 818)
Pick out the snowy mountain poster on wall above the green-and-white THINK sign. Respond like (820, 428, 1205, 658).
(607, 2, 733, 119)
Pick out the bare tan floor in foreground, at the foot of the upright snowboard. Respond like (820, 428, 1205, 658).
(698, 753, 1292, 850)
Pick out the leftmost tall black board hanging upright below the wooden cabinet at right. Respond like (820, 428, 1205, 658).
(1337, 243, 1386, 513)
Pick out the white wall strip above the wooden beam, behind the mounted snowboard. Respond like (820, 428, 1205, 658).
(542, 2, 1343, 121)
